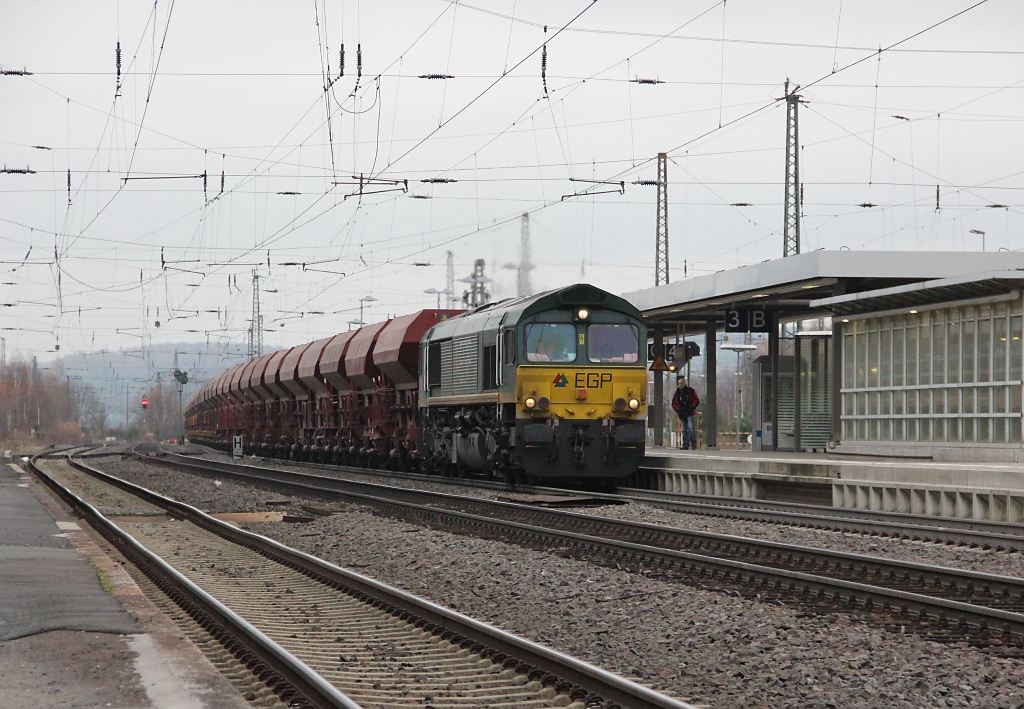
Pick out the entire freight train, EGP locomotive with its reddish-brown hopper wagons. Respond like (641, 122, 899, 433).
(185, 284, 647, 483)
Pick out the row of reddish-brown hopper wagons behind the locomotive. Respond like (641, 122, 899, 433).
(185, 309, 452, 469)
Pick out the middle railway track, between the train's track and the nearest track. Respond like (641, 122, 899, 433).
(138, 450, 1024, 657)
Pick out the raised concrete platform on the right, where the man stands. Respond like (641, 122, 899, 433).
(630, 447, 1024, 523)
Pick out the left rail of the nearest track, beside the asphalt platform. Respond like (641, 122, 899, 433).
(29, 458, 361, 709)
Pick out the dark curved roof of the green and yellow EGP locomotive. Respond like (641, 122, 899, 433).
(426, 283, 643, 339)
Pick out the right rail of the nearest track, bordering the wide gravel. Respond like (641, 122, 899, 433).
(69, 457, 693, 709)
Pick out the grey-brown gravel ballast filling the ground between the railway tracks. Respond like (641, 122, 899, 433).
(92, 459, 1024, 708)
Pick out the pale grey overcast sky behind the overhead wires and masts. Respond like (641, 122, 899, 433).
(0, 0, 1024, 364)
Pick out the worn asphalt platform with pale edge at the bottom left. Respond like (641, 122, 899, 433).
(0, 460, 248, 709)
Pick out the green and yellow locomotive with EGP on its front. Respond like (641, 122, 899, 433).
(420, 284, 647, 483)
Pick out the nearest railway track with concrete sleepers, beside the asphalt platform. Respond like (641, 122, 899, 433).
(30, 458, 689, 709)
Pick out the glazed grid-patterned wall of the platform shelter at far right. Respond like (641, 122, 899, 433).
(842, 298, 1022, 445)
